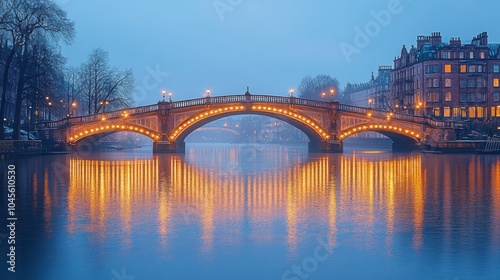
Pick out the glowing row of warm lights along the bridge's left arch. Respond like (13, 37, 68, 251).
(69, 124, 160, 144)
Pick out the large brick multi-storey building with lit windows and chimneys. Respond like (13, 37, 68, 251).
(391, 32, 500, 120)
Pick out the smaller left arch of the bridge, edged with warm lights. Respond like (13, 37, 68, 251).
(68, 122, 161, 145)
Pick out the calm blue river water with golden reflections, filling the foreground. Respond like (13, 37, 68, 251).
(0, 145, 500, 280)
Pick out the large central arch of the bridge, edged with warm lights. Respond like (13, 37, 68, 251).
(168, 105, 330, 143)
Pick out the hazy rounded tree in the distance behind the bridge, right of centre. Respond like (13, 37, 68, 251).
(297, 75, 339, 100)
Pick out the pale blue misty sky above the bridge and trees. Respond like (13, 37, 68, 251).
(56, 0, 500, 105)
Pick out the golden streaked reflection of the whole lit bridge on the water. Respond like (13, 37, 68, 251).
(44, 148, 500, 255)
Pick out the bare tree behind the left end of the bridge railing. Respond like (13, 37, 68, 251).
(79, 49, 135, 115)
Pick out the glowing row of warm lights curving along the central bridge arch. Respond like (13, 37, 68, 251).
(169, 105, 330, 141)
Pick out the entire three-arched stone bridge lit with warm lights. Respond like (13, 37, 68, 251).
(38, 92, 463, 152)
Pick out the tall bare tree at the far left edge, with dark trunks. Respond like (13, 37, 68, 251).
(0, 0, 75, 140)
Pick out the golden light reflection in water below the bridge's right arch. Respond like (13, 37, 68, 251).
(337, 153, 425, 250)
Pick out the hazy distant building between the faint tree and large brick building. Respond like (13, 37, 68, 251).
(344, 66, 392, 110)
